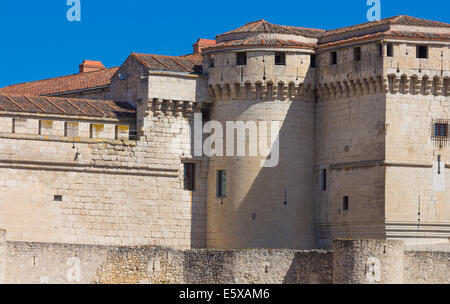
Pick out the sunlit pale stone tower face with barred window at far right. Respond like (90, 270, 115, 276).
(384, 43, 450, 243)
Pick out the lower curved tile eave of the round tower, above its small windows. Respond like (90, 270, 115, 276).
(206, 37, 316, 51)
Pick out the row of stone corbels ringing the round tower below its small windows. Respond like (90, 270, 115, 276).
(208, 81, 314, 101)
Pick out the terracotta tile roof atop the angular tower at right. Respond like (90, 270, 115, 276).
(322, 15, 450, 37)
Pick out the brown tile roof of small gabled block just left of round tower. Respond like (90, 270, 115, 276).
(132, 53, 202, 73)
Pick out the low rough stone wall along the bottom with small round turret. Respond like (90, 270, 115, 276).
(0, 240, 450, 284)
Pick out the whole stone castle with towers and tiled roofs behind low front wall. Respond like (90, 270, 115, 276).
(0, 16, 450, 260)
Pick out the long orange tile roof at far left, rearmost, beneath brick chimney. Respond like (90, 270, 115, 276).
(0, 67, 119, 95)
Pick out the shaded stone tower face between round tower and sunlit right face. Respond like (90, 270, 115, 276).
(314, 43, 386, 248)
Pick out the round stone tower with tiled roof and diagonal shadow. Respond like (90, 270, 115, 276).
(203, 20, 320, 249)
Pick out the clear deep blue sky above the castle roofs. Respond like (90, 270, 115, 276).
(0, 0, 450, 87)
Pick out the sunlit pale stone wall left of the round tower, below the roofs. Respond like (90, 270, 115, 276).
(0, 107, 207, 248)
